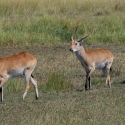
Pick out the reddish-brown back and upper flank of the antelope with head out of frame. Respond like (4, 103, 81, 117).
(0, 51, 37, 70)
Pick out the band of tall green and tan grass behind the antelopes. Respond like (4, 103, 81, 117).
(0, 0, 125, 46)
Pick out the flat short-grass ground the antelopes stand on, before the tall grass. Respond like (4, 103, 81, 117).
(0, 44, 125, 125)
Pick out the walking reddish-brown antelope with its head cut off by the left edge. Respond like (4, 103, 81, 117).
(0, 51, 38, 102)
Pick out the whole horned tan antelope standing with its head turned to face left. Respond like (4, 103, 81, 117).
(70, 28, 114, 90)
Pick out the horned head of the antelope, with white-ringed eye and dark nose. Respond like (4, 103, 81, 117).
(70, 27, 90, 52)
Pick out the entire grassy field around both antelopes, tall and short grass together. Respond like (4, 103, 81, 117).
(0, 0, 125, 125)
